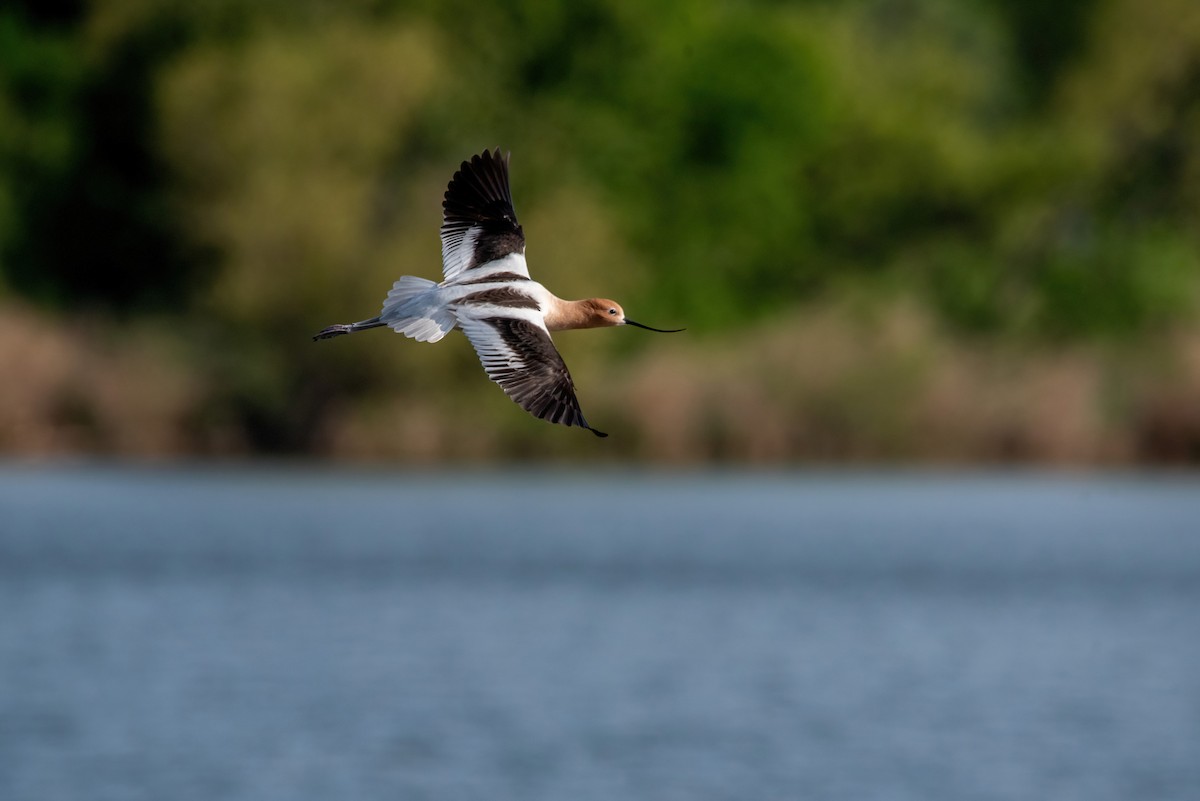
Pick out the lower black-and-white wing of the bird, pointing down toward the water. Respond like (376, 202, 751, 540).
(458, 315, 607, 436)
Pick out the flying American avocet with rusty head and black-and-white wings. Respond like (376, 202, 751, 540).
(313, 149, 683, 436)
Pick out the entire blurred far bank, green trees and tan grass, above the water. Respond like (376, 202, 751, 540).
(7, 0, 1200, 464)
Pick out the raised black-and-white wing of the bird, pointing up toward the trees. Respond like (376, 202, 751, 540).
(442, 149, 529, 281)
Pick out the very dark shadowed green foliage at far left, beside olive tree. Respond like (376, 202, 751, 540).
(0, 2, 211, 309)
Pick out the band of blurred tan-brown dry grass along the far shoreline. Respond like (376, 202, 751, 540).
(7, 298, 1200, 465)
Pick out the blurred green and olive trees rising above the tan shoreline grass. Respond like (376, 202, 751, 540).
(0, 0, 1200, 448)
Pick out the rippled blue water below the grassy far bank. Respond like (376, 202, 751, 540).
(0, 465, 1200, 801)
